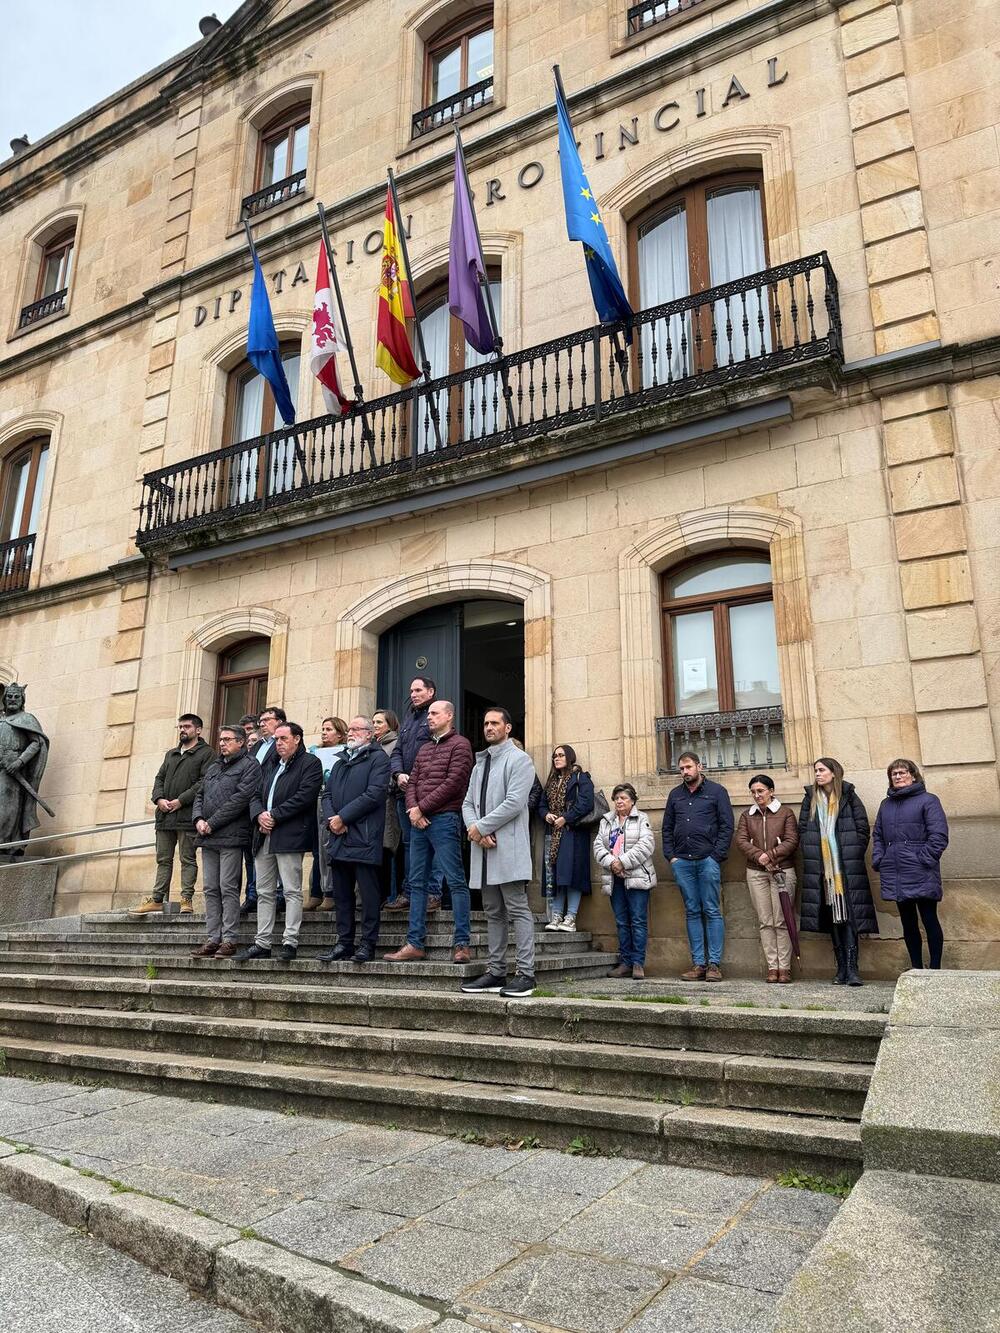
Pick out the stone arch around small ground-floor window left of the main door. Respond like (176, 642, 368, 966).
(177, 607, 288, 717)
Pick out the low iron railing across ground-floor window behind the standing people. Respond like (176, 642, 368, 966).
(656, 705, 788, 773)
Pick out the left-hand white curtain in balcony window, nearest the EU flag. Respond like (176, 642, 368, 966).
(639, 207, 693, 388)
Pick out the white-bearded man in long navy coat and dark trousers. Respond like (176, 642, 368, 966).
(320, 717, 389, 962)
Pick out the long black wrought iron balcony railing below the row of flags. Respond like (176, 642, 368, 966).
(137, 253, 841, 545)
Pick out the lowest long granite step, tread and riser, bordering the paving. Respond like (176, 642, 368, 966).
(4, 1029, 861, 1174)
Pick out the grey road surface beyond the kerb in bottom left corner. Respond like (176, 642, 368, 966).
(0, 1189, 256, 1333)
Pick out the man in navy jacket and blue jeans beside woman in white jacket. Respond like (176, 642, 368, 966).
(663, 750, 733, 981)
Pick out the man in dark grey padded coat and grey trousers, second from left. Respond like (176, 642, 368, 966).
(192, 726, 260, 958)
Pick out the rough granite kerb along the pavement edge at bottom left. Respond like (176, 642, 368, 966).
(0, 1146, 448, 1333)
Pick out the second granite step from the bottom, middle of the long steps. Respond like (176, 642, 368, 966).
(0, 1002, 871, 1118)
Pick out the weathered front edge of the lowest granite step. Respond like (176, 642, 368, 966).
(4, 1037, 861, 1164)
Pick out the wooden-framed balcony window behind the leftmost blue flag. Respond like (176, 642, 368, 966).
(220, 343, 300, 505)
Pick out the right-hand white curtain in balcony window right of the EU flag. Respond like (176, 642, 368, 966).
(707, 185, 771, 365)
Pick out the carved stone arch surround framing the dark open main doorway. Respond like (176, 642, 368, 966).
(333, 560, 553, 765)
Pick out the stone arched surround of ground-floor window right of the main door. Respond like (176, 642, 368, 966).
(619, 505, 819, 788)
